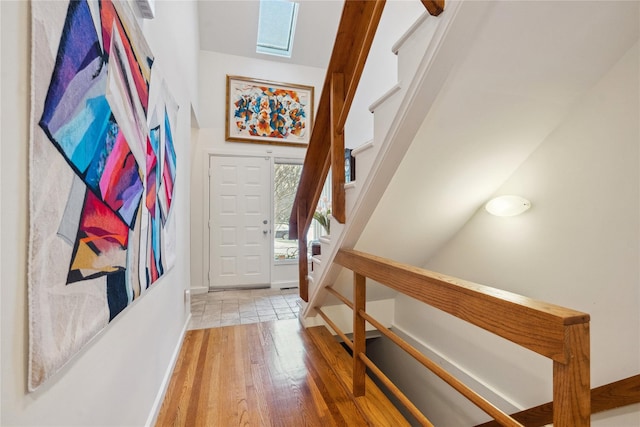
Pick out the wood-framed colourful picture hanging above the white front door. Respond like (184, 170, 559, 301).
(225, 75, 314, 147)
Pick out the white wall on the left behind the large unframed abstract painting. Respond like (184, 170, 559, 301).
(0, 1, 198, 426)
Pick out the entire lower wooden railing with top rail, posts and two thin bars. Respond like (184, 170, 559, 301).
(314, 249, 592, 427)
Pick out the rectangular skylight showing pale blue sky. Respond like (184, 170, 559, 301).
(256, 0, 298, 58)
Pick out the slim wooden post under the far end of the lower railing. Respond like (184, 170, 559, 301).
(353, 273, 367, 397)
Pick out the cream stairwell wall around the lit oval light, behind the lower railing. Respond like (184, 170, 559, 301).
(382, 43, 640, 427)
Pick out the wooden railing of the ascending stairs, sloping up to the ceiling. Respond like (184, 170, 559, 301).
(289, 0, 445, 301)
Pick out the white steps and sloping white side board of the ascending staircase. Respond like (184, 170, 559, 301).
(303, 2, 478, 331)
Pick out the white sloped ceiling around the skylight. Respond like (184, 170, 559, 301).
(198, 0, 343, 68)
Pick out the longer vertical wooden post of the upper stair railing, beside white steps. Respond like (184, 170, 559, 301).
(331, 73, 347, 224)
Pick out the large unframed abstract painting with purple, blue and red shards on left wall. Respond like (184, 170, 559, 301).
(28, 0, 178, 390)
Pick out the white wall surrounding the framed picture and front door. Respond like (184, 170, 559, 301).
(191, 51, 325, 292)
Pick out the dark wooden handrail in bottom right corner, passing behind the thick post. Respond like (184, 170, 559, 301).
(476, 374, 640, 427)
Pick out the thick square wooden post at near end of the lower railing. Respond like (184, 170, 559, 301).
(553, 323, 591, 427)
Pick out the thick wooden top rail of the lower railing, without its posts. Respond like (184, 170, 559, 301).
(335, 249, 589, 363)
